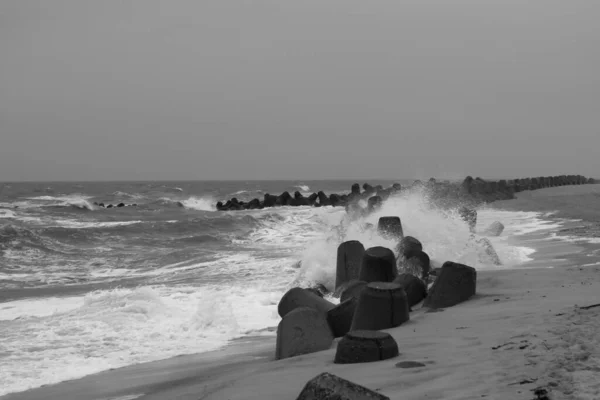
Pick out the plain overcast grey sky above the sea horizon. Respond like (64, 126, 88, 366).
(0, 0, 600, 181)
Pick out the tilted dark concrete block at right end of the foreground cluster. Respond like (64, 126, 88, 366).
(423, 261, 477, 308)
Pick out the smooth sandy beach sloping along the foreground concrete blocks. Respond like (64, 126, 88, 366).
(1, 185, 600, 400)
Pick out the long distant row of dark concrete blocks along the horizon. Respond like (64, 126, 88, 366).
(216, 175, 596, 211)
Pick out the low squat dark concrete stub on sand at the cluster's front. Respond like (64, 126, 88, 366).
(333, 330, 399, 364)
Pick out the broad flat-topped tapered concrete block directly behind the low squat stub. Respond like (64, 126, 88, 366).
(350, 282, 410, 331)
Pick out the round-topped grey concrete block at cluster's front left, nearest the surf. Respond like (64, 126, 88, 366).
(275, 307, 333, 360)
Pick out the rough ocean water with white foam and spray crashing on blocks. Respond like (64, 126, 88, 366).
(0, 181, 572, 395)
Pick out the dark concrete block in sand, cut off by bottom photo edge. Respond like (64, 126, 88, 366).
(296, 372, 390, 400)
